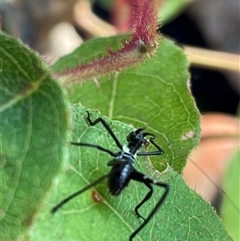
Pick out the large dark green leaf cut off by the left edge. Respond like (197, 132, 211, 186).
(0, 32, 69, 241)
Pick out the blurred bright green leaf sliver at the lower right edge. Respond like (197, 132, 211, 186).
(221, 149, 240, 240)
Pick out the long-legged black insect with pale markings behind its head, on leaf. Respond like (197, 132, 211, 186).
(51, 112, 169, 241)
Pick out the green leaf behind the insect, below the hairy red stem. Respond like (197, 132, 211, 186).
(55, 36, 200, 172)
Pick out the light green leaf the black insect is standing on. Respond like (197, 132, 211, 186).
(29, 104, 231, 241)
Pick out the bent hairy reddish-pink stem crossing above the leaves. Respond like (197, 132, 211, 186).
(52, 1, 160, 84)
